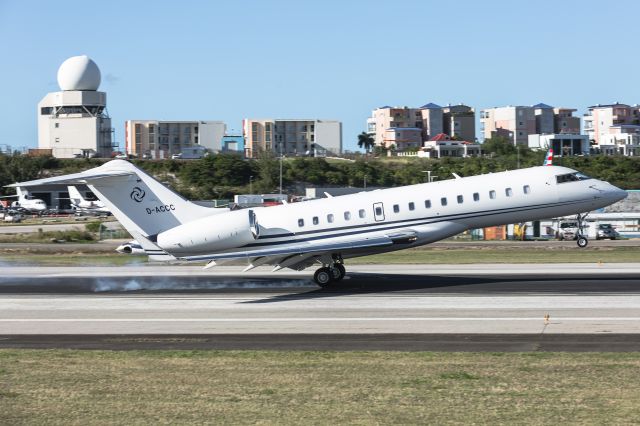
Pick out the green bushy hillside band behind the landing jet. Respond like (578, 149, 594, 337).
(0, 149, 640, 199)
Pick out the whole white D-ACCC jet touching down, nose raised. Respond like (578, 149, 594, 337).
(9, 160, 626, 287)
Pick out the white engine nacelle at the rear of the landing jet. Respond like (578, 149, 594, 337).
(157, 210, 258, 253)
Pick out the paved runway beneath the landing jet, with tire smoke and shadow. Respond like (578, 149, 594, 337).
(0, 264, 640, 350)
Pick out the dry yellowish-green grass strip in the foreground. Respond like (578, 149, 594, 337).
(0, 350, 640, 424)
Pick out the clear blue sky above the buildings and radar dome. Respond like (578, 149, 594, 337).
(0, 0, 640, 149)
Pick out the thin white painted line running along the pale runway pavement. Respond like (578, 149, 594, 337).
(0, 317, 640, 324)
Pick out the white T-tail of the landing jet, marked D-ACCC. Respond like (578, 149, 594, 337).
(9, 160, 226, 239)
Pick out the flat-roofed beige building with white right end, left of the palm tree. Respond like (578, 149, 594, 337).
(242, 118, 342, 158)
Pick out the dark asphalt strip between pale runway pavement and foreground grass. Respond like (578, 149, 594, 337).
(0, 334, 640, 352)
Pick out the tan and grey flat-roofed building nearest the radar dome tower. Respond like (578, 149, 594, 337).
(125, 120, 226, 159)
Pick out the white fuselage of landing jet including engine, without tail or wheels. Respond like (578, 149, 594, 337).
(157, 166, 626, 257)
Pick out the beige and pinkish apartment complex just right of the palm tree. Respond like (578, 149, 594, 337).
(367, 103, 476, 150)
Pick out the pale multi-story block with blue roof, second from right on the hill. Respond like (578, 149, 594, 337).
(480, 103, 580, 145)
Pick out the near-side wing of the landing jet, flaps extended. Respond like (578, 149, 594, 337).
(178, 230, 416, 270)
